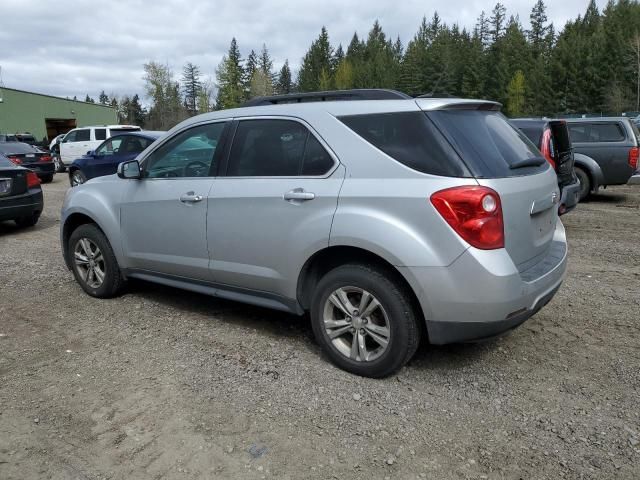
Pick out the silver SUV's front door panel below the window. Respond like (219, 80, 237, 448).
(120, 177, 213, 280)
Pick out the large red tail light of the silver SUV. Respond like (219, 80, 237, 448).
(431, 186, 504, 250)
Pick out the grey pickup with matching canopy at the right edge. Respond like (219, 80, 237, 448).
(567, 117, 640, 199)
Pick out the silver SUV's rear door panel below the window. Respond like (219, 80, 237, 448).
(207, 166, 344, 298)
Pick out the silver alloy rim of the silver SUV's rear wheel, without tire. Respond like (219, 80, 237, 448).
(323, 286, 391, 362)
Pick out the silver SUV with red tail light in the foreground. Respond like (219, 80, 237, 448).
(61, 92, 567, 377)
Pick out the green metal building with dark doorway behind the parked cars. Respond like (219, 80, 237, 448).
(0, 87, 118, 140)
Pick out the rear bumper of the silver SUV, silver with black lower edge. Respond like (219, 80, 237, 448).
(399, 221, 567, 345)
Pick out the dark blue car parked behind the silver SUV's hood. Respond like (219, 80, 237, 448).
(69, 131, 165, 187)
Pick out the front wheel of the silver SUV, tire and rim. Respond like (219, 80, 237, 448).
(67, 224, 124, 298)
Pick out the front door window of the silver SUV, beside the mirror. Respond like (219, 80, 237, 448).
(144, 122, 225, 178)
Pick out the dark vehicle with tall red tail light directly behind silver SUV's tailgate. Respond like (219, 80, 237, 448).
(511, 118, 580, 215)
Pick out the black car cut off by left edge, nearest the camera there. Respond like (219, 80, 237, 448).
(0, 153, 44, 227)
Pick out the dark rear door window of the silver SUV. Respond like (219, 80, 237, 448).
(227, 120, 333, 177)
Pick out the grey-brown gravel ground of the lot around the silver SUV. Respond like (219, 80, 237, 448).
(0, 175, 640, 480)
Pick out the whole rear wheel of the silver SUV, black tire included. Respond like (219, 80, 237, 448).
(311, 264, 420, 378)
